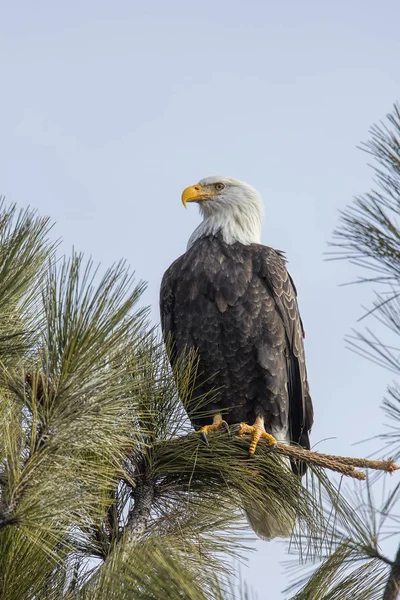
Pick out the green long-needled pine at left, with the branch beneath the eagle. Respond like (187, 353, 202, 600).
(0, 200, 335, 600)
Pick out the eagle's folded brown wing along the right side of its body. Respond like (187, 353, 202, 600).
(254, 245, 313, 468)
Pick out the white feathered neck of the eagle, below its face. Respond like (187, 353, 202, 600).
(187, 211, 262, 249)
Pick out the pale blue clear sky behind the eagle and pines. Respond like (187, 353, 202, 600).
(0, 0, 400, 600)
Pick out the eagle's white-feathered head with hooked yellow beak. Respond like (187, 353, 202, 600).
(182, 176, 263, 248)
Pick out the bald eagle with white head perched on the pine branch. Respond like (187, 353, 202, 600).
(160, 177, 313, 538)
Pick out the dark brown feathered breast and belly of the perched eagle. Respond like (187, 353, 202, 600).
(162, 236, 288, 431)
